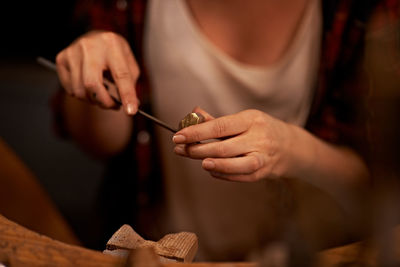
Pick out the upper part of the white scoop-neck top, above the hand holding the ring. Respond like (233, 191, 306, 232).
(145, 0, 320, 125)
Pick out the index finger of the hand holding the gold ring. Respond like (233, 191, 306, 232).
(173, 113, 249, 144)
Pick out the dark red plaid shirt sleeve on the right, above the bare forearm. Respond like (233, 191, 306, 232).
(306, 0, 400, 163)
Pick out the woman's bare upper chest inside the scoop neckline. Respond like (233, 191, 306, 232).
(186, 0, 309, 66)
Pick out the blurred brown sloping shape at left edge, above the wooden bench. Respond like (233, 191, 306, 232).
(0, 138, 80, 245)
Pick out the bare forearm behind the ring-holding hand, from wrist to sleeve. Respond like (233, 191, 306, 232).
(285, 126, 370, 216)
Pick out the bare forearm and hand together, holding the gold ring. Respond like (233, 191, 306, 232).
(173, 108, 369, 218)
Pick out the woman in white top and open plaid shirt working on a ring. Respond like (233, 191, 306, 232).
(56, 0, 400, 260)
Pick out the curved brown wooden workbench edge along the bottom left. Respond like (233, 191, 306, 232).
(0, 215, 256, 267)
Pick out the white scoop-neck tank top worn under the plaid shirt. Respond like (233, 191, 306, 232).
(145, 0, 322, 260)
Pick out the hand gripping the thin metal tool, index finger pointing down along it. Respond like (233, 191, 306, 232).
(56, 31, 140, 115)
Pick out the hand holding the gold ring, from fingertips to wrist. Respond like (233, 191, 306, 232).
(173, 108, 293, 182)
